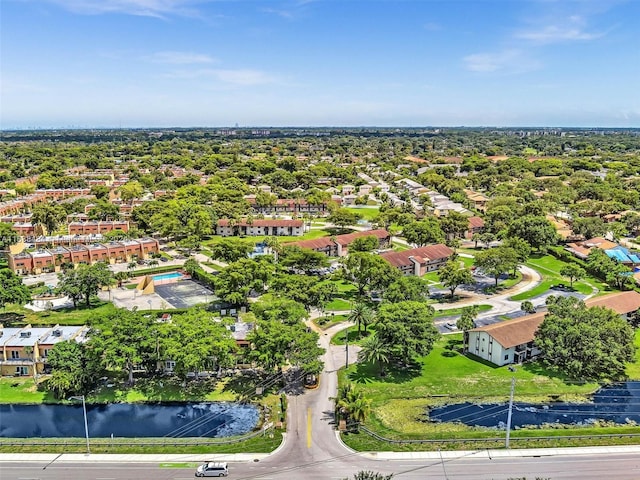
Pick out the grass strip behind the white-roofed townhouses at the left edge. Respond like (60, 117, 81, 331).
(0, 301, 116, 326)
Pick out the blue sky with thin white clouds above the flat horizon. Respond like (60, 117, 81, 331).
(0, 0, 640, 129)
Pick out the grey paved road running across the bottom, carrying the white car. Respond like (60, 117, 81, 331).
(0, 451, 640, 480)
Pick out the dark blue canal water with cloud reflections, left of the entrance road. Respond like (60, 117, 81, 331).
(0, 402, 260, 438)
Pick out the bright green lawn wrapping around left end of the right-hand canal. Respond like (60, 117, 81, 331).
(340, 335, 598, 438)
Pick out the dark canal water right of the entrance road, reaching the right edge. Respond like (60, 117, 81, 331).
(429, 382, 640, 429)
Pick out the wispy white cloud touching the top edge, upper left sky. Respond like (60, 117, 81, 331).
(48, 0, 203, 18)
